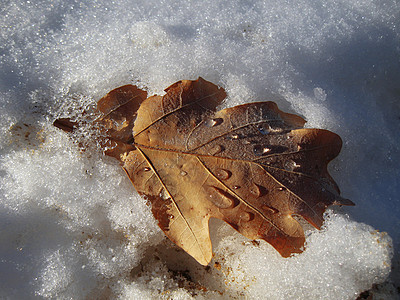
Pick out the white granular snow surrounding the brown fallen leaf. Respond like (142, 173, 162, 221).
(0, 0, 400, 299)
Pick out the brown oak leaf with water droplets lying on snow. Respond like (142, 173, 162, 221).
(55, 78, 354, 265)
